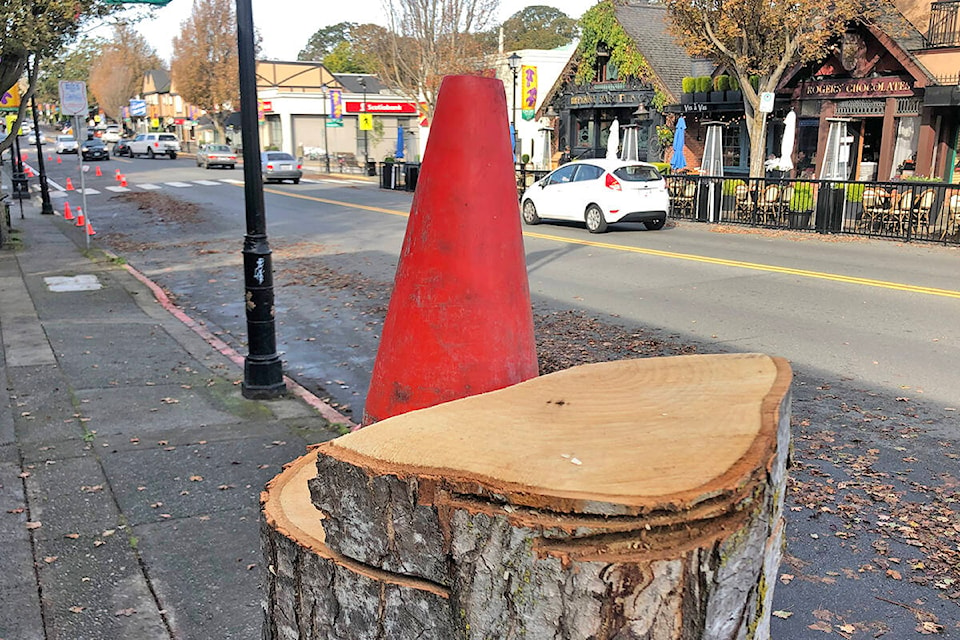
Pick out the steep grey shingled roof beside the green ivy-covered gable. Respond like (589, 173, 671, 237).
(614, 0, 692, 99)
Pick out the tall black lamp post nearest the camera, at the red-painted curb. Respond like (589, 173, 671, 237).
(237, 0, 287, 399)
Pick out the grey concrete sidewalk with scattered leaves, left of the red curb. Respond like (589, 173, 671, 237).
(0, 200, 344, 640)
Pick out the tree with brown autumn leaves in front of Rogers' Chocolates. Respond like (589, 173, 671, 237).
(664, 0, 876, 176)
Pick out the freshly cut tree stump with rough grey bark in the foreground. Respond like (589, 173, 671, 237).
(262, 354, 791, 640)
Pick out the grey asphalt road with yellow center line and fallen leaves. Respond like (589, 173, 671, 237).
(14, 146, 960, 639)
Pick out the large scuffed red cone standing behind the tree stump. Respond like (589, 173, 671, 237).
(363, 76, 537, 425)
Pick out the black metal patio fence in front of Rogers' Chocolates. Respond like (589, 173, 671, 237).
(667, 175, 960, 244)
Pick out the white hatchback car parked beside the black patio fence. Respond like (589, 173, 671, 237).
(520, 158, 670, 233)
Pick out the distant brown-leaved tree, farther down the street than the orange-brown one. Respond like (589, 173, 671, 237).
(90, 24, 162, 121)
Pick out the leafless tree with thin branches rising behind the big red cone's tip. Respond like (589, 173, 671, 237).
(377, 0, 500, 116)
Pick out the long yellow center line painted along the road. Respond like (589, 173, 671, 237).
(255, 185, 960, 299)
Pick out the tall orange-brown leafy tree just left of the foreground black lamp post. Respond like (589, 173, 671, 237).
(170, 0, 240, 137)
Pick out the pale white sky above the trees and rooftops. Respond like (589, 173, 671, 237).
(120, 0, 596, 62)
